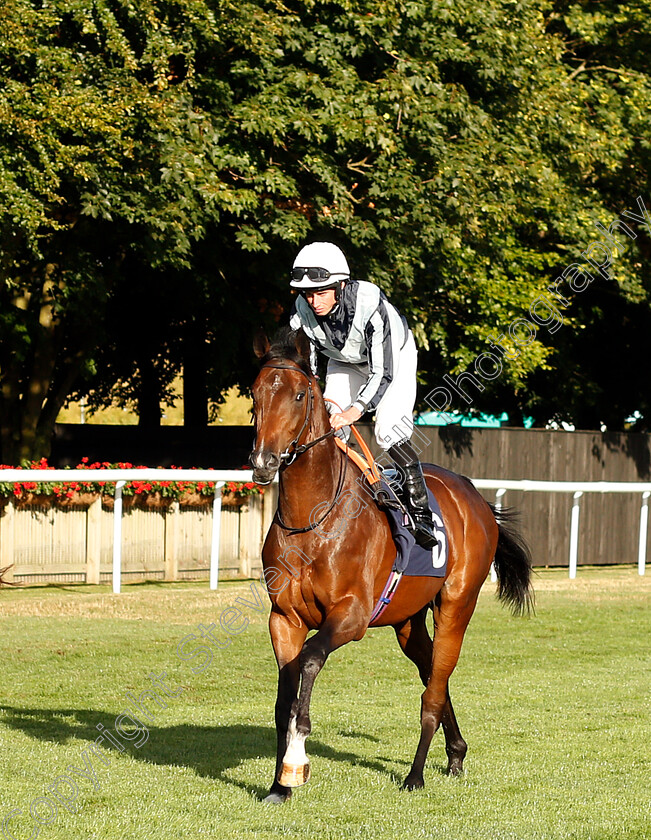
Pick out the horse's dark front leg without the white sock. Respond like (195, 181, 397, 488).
(264, 611, 308, 805)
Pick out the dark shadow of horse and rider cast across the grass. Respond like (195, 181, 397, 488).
(0, 706, 402, 798)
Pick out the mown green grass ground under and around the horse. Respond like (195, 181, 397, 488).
(0, 567, 651, 840)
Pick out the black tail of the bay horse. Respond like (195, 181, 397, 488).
(491, 505, 534, 615)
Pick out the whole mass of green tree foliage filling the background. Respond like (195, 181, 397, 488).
(0, 0, 651, 460)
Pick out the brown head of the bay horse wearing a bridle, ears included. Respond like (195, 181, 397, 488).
(249, 328, 314, 484)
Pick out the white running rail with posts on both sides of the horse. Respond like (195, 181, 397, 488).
(0, 469, 651, 593)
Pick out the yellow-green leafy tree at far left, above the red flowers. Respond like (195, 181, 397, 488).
(0, 0, 247, 461)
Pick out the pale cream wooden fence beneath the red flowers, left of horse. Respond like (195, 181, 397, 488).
(0, 488, 277, 584)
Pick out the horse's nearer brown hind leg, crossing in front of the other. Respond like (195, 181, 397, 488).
(403, 587, 478, 790)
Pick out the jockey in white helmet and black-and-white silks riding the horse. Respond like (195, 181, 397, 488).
(290, 242, 437, 548)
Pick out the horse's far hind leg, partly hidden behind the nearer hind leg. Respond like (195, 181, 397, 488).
(394, 607, 468, 776)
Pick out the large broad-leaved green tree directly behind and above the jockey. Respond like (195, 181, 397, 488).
(197, 2, 648, 422)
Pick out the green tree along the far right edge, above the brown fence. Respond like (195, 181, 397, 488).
(522, 0, 651, 430)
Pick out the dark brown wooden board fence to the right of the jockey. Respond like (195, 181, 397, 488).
(364, 426, 651, 566)
